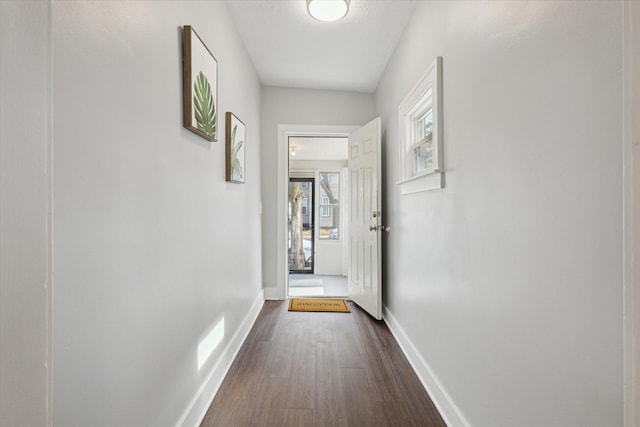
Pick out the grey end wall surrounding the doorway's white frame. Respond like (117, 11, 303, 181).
(261, 87, 374, 296)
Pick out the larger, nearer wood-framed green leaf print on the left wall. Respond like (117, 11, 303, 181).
(182, 25, 218, 141)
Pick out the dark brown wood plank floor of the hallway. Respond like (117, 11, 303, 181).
(201, 301, 446, 427)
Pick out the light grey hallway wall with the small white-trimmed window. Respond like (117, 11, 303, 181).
(376, 1, 623, 427)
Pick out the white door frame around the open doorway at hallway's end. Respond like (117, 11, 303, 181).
(264, 124, 361, 300)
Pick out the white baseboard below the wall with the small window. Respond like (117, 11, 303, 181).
(382, 306, 470, 427)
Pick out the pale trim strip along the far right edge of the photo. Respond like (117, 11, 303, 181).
(622, 0, 640, 427)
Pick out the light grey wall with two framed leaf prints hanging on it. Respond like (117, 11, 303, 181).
(53, 1, 262, 426)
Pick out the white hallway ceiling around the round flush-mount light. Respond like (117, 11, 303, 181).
(227, 0, 415, 93)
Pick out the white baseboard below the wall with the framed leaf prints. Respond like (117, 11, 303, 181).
(176, 291, 265, 427)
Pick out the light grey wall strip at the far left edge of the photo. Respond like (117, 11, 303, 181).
(0, 0, 51, 427)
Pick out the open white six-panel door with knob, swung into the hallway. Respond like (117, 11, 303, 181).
(349, 118, 383, 319)
